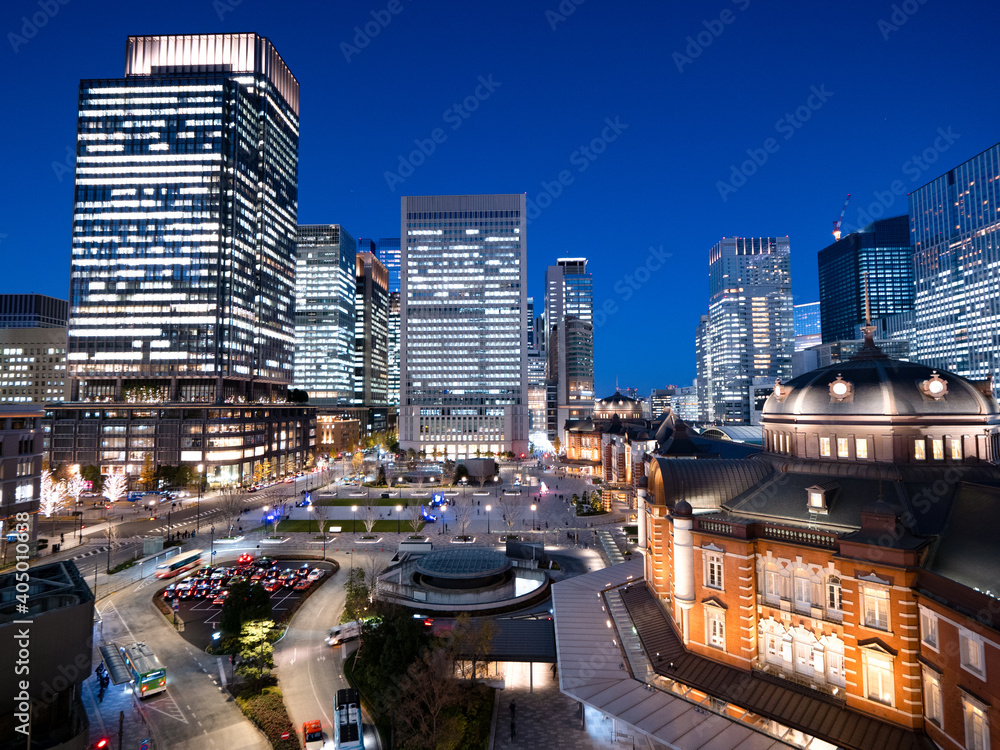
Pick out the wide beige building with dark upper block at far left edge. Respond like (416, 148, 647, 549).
(0, 294, 69, 404)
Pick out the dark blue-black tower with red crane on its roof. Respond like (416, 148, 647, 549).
(817, 215, 913, 343)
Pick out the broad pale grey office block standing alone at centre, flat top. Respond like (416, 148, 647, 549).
(399, 194, 528, 458)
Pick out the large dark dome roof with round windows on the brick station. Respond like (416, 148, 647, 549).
(762, 346, 1000, 422)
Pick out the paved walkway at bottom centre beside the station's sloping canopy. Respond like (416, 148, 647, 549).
(493, 664, 666, 750)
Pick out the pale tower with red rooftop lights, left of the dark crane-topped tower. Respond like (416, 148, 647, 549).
(708, 237, 794, 424)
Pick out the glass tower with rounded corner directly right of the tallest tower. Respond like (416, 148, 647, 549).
(295, 224, 358, 406)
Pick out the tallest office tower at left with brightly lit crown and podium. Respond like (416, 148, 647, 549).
(54, 34, 309, 481)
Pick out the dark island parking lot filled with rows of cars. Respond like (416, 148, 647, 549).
(156, 558, 334, 650)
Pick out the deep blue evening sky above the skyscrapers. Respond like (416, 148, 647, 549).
(0, 0, 1000, 395)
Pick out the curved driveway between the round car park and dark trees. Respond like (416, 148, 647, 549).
(274, 559, 381, 750)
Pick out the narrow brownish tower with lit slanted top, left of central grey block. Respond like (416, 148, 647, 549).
(354, 252, 389, 406)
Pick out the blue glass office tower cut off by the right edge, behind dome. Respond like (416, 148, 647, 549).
(910, 144, 1000, 378)
